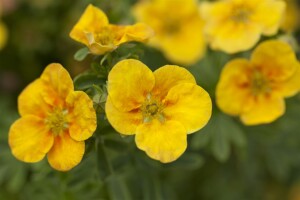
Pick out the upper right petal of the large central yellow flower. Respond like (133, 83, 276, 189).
(152, 65, 196, 99)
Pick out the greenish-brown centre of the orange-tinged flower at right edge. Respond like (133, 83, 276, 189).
(251, 70, 271, 96)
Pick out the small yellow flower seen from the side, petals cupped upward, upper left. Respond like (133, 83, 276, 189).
(70, 4, 153, 55)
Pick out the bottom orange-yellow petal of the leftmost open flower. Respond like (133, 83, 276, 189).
(48, 133, 85, 171)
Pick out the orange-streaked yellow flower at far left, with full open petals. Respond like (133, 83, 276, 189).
(9, 64, 97, 171)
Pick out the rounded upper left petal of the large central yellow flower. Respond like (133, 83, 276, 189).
(107, 59, 154, 111)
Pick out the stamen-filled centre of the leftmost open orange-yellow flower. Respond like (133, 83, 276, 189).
(45, 109, 68, 135)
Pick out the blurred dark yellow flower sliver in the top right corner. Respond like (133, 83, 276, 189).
(281, 0, 300, 32)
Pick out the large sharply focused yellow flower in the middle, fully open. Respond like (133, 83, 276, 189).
(105, 59, 212, 163)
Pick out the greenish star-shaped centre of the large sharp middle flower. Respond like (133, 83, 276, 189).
(141, 94, 164, 123)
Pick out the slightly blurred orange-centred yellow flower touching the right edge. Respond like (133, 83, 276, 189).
(216, 40, 300, 125)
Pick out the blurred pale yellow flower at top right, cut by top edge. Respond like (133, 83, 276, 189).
(201, 0, 285, 53)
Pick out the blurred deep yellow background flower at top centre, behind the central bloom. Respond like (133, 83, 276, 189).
(133, 0, 206, 65)
